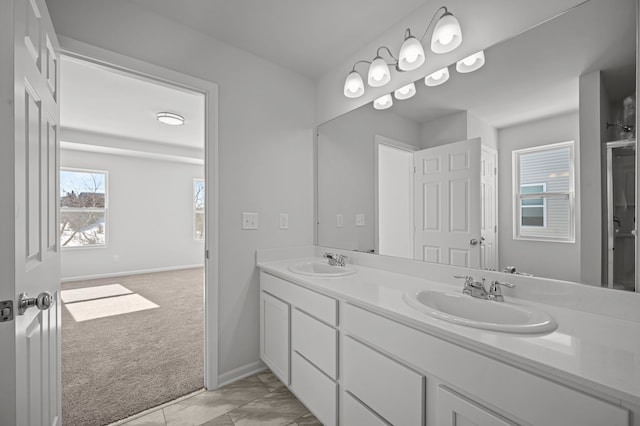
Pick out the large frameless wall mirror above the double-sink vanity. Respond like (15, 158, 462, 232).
(317, 0, 637, 291)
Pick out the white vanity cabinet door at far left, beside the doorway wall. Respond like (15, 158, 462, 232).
(260, 291, 291, 385)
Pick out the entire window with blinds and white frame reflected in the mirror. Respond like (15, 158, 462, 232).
(513, 142, 575, 242)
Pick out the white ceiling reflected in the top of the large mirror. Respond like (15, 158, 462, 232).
(391, 0, 635, 128)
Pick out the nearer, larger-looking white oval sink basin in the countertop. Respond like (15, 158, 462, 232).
(404, 290, 558, 333)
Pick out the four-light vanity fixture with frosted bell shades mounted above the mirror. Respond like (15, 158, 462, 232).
(344, 6, 462, 98)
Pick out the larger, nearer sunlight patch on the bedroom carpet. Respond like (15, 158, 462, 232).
(65, 294, 158, 322)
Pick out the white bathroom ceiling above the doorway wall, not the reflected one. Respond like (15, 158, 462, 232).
(129, 0, 426, 78)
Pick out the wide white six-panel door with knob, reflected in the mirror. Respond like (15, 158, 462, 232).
(414, 139, 481, 268)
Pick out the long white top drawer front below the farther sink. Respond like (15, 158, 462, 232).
(260, 272, 338, 326)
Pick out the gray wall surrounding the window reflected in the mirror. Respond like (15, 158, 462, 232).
(498, 112, 581, 282)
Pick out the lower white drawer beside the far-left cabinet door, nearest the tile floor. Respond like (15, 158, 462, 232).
(291, 351, 338, 426)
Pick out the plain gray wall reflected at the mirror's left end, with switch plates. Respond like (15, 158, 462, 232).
(318, 105, 420, 250)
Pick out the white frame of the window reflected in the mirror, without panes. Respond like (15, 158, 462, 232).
(511, 141, 576, 243)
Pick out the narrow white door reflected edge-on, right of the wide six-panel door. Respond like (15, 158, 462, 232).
(480, 146, 498, 270)
